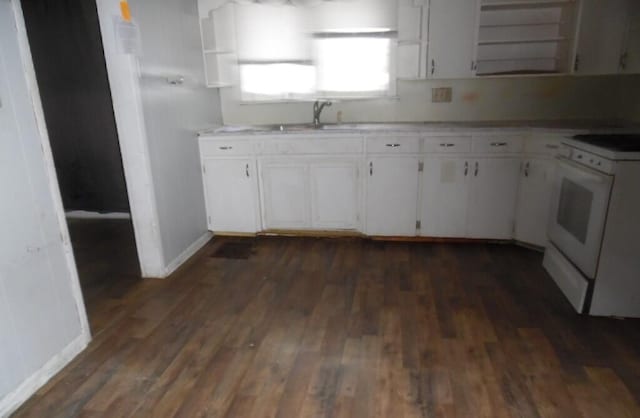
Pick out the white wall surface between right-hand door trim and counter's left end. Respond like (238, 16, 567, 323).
(130, 0, 221, 264)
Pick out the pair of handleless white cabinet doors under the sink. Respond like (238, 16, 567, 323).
(261, 158, 360, 230)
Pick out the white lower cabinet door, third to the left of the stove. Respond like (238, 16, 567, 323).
(420, 157, 471, 237)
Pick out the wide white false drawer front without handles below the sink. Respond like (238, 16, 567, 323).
(262, 137, 362, 155)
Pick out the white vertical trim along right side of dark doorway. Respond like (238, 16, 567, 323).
(96, 0, 166, 277)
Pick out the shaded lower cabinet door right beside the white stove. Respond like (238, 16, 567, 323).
(515, 158, 556, 247)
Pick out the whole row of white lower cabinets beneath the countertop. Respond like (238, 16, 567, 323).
(200, 131, 567, 246)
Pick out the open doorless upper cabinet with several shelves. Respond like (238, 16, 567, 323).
(476, 0, 577, 76)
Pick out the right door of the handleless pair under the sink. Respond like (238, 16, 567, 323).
(309, 161, 360, 229)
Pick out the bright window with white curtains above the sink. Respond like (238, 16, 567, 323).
(236, 0, 396, 101)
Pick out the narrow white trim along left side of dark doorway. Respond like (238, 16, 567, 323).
(10, 0, 91, 342)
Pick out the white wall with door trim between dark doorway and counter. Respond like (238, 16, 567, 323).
(96, 0, 221, 277)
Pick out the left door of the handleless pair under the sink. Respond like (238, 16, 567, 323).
(261, 162, 310, 229)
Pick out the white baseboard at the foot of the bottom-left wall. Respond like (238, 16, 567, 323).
(0, 332, 91, 417)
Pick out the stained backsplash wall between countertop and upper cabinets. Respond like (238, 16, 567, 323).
(221, 76, 640, 125)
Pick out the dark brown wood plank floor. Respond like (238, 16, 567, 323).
(15, 227, 640, 418)
